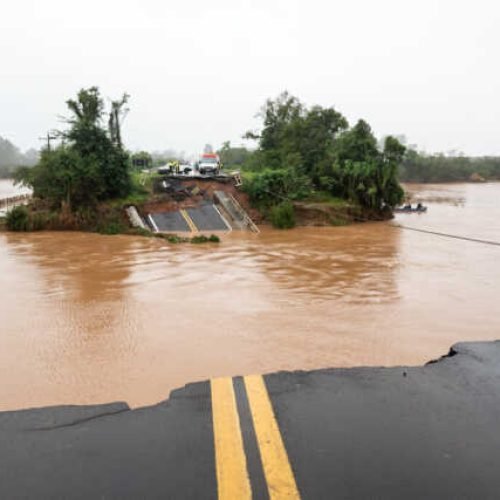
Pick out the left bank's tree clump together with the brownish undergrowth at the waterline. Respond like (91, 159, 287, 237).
(6, 87, 147, 234)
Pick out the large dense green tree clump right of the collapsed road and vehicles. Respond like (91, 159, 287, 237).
(244, 92, 405, 211)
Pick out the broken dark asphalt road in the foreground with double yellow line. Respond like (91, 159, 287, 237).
(0, 342, 500, 499)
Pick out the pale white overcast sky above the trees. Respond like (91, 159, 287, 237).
(0, 0, 500, 155)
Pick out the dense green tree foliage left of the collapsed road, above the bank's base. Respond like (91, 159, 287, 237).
(17, 87, 131, 211)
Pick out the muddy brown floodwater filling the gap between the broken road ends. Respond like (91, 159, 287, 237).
(0, 184, 500, 409)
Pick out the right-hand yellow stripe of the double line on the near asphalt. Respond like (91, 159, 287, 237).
(245, 375, 300, 500)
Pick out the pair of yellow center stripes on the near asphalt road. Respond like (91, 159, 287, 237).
(211, 375, 300, 500)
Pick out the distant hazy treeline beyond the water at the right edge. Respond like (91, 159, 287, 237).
(399, 149, 500, 182)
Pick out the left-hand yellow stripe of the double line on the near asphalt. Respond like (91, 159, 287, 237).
(210, 377, 252, 500)
